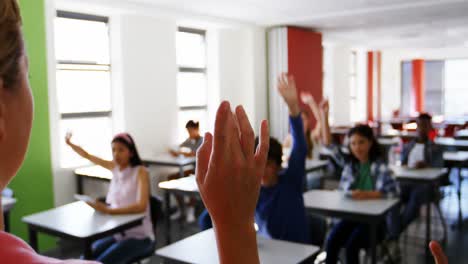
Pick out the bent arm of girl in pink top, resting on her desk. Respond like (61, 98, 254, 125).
(88, 166, 150, 215)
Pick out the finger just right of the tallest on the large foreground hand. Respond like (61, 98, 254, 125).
(236, 105, 255, 161)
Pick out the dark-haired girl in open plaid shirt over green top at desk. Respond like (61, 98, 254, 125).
(321, 101, 398, 264)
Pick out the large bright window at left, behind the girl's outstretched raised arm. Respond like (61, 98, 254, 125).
(54, 11, 113, 168)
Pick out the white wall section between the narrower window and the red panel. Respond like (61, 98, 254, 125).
(218, 28, 267, 130)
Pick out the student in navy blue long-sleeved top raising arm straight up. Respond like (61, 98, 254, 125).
(199, 74, 310, 243)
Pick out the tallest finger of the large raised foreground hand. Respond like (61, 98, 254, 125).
(213, 101, 232, 157)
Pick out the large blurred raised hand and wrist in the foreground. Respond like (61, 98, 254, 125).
(196, 102, 269, 264)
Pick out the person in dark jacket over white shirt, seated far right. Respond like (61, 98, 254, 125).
(400, 113, 444, 230)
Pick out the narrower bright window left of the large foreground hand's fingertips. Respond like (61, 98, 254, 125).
(176, 27, 208, 141)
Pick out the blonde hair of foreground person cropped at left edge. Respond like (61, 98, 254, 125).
(0, 0, 24, 88)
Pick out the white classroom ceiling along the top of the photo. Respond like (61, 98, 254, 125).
(76, 0, 468, 48)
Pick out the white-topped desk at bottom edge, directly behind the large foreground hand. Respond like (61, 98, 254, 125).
(156, 229, 320, 264)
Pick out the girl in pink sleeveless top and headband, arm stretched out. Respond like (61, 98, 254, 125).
(65, 133, 155, 263)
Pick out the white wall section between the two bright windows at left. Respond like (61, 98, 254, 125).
(120, 15, 178, 156)
